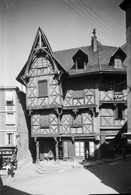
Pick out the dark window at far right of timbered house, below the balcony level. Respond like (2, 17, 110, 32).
(114, 104, 125, 120)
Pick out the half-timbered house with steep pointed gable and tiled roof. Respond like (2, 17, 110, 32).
(17, 28, 127, 161)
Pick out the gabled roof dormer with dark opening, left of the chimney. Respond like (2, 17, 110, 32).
(72, 49, 88, 70)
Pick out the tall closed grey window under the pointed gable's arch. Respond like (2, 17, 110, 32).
(38, 80, 48, 97)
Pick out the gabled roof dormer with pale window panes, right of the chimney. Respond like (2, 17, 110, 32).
(109, 48, 126, 69)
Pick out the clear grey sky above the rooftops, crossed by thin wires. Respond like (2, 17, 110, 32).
(0, 0, 126, 88)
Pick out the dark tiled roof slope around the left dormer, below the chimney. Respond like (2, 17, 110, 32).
(53, 42, 117, 71)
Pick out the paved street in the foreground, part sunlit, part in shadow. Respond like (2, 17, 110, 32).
(2, 159, 131, 195)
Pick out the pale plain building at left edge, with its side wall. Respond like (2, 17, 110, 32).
(0, 87, 29, 167)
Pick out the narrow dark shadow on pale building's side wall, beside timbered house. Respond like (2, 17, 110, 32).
(17, 91, 36, 162)
